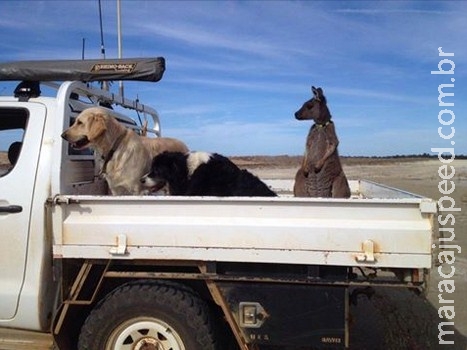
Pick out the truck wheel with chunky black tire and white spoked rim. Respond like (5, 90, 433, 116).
(78, 281, 217, 350)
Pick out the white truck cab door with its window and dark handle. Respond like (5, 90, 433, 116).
(0, 102, 46, 320)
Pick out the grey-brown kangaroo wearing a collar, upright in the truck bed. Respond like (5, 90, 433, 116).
(294, 86, 350, 198)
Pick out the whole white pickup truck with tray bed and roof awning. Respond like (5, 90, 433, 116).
(0, 58, 437, 350)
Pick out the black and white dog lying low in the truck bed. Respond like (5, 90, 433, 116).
(141, 152, 276, 197)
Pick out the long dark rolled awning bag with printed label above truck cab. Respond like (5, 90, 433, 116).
(0, 57, 165, 82)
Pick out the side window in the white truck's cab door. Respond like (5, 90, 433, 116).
(0, 108, 29, 177)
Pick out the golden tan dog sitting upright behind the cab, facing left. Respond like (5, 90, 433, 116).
(62, 107, 152, 195)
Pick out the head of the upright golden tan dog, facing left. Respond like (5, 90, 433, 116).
(62, 107, 112, 149)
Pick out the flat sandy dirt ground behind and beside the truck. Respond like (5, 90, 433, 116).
(233, 156, 467, 350)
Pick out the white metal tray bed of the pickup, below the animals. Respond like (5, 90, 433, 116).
(49, 180, 436, 269)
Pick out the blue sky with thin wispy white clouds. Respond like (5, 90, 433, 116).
(0, 0, 467, 156)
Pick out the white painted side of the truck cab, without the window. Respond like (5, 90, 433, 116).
(0, 98, 56, 330)
